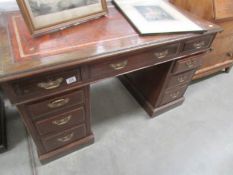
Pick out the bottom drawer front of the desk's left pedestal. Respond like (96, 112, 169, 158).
(42, 124, 86, 151)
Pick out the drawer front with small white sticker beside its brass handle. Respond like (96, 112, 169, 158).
(12, 68, 81, 98)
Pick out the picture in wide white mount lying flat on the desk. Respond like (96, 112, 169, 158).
(114, 0, 205, 35)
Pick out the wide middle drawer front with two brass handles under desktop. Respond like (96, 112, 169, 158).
(90, 43, 180, 79)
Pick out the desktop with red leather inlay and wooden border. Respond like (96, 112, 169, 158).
(0, 6, 221, 81)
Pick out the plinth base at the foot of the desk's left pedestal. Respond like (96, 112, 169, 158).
(39, 134, 94, 164)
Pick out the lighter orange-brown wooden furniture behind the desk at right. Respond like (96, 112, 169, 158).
(170, 0, 233, 79)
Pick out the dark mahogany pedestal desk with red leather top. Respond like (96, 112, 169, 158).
(0, 7, 221, 162)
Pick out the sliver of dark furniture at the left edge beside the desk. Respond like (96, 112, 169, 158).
(0, 98, 7, 153)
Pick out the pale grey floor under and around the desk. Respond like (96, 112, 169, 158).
(0, 72, 233, 175)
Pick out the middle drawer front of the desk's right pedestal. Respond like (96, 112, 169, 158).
(167, 69, 196, 88)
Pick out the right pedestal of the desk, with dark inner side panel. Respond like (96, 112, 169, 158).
(120, 56, 201, 117)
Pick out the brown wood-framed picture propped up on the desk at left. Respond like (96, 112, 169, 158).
(17, 0, 107, 36)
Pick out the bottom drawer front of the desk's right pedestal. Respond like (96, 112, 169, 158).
(161, 85, 188, 105)
